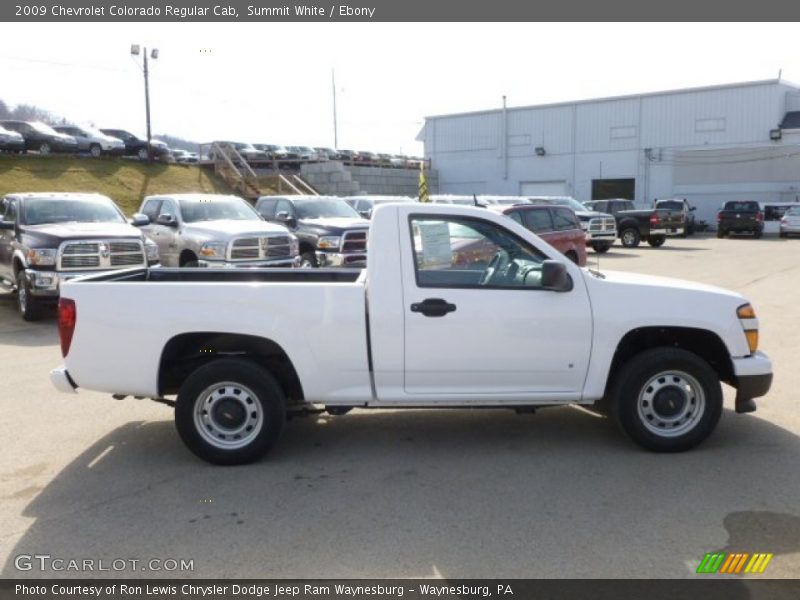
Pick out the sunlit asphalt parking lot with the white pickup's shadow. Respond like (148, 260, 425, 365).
(0, 237, 800, 578)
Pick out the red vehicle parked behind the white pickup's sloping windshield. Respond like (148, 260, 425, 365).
(490, 204, 586, 267)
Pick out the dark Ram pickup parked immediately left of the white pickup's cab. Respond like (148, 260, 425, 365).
(256, 196, 369, 267)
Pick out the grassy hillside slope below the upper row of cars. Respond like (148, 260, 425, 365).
(0, 155, 236, 215)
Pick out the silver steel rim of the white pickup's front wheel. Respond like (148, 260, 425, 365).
(636, 371, 706, 438)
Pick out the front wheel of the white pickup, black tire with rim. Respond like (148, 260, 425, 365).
(611, 348, 722, 452)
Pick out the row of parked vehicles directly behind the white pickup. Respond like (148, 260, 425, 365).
(0, 193, 692, 320)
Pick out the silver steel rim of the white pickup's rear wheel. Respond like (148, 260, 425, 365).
(194, 381, 264, 450)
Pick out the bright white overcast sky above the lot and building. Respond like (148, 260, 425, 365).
(0, 23, 800, 154)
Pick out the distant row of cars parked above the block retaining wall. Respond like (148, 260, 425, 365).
(209, 141, 423, 168)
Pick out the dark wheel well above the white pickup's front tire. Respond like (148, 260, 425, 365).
(606, 327, 734, 393)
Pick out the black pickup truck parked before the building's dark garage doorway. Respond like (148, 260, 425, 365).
(584, 199, 686, 248)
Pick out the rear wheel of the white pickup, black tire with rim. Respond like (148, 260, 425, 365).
(175, 358, 286, 465)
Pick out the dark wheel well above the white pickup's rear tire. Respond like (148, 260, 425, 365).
(158, 331, 304, 404)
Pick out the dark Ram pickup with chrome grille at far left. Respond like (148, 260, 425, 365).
(0, 193, 158, 321)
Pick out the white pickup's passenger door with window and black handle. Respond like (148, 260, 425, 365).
(401, 209, 592, 403)
